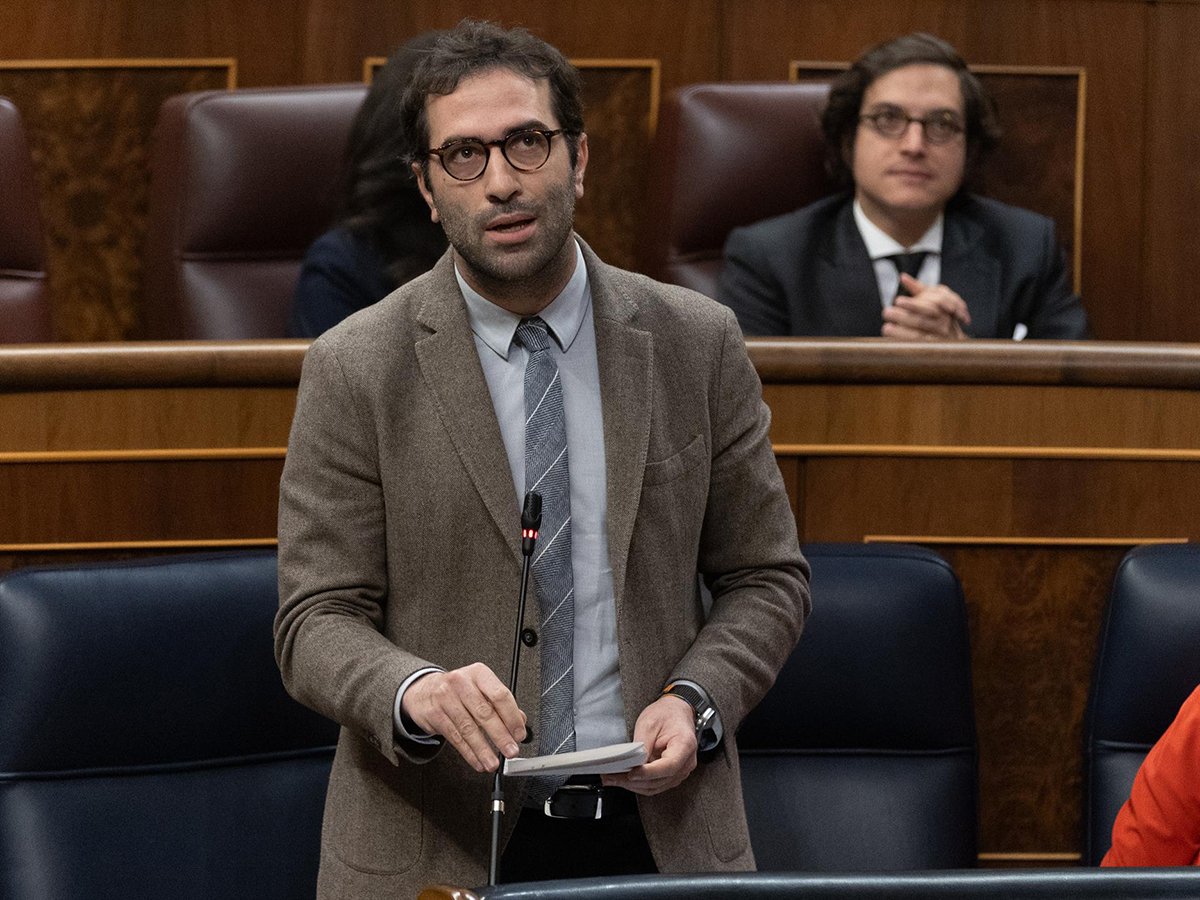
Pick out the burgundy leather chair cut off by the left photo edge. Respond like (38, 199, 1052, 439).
(0, 97, 50, 343)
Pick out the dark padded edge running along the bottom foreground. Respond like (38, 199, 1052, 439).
(463, 869, 1200, 900)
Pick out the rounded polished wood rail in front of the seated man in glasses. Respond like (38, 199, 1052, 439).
(748, 337, 1200, 389)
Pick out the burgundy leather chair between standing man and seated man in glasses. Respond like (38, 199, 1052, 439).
(642, 82, 834, 296)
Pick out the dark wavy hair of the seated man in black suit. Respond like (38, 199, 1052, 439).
(821, 31, 1000, 186)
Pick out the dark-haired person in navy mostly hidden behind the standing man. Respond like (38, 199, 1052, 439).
(288, 31, 446, 337)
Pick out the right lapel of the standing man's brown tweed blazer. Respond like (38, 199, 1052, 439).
(581, 241, 654, 614)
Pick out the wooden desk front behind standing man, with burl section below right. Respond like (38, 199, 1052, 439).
(0, 340, 1200, 865)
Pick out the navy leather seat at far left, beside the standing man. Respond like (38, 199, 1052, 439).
(0, 552, 337, 900)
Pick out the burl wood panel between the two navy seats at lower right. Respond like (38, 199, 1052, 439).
(934, 545, 1129, 865)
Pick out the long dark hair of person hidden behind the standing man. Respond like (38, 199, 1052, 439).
(338, 31, 446, 284)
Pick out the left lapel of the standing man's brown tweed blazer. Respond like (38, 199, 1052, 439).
(416, 253, 521, 560)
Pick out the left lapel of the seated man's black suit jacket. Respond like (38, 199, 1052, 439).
(811, 200, 883, 337)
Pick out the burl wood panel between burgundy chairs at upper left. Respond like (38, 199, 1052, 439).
(0, 59, 235, 341)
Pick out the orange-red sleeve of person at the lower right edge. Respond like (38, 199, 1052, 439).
(1100, 688, 1200, 865)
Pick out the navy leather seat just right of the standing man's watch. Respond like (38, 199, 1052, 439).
(738, 544, 978, 871)
